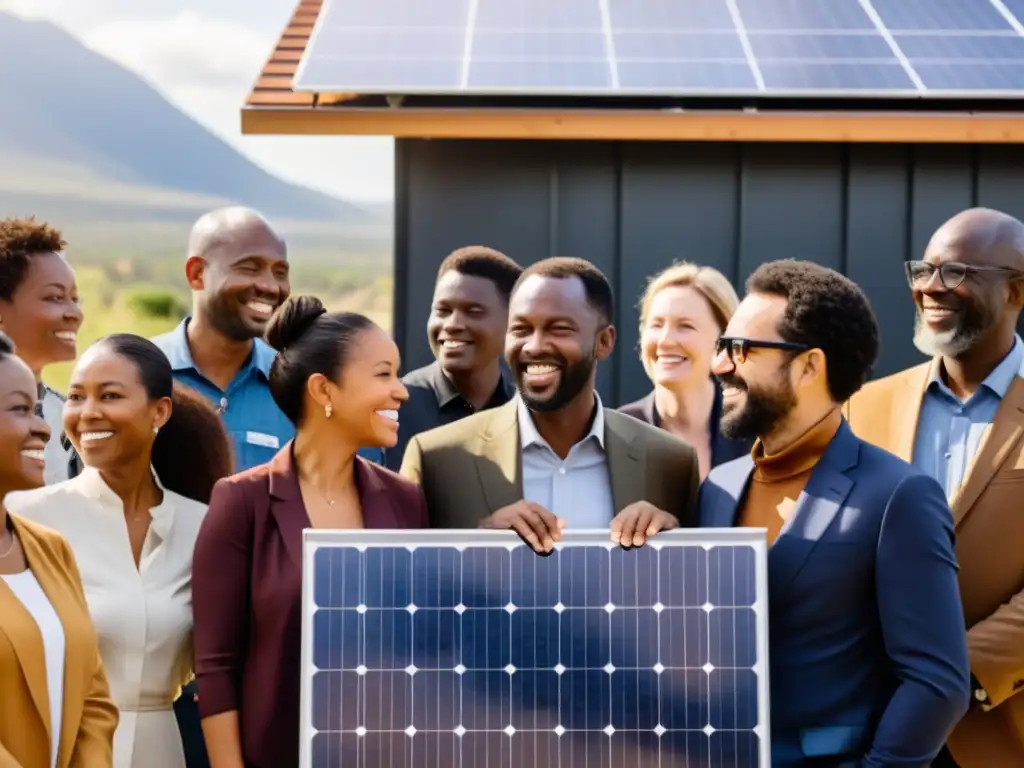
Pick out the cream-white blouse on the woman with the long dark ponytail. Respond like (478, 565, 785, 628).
(5, 468, 206, 768)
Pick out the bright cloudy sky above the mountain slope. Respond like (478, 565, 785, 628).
(0, 0, 394, 202)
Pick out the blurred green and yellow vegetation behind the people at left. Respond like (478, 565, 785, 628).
(43, 246, 391, 392)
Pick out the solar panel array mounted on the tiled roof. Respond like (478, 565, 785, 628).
(294, 0, 1024, 96)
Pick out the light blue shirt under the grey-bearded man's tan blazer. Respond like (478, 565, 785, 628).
(913, 336, 1024, 499)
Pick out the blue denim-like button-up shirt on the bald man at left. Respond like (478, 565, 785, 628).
(153, 317, 382, 471)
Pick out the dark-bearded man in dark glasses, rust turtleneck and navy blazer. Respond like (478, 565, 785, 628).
(699, 261, 970, 768)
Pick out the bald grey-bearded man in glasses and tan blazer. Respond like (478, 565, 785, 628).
(847, 209, 1024, 768)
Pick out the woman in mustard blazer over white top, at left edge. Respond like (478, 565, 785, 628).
(0, 334, 118, 768)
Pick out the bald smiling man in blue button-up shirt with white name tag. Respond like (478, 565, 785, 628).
(154, 207, 381, 471)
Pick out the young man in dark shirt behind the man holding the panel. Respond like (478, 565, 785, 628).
(385, 246, 522, 471)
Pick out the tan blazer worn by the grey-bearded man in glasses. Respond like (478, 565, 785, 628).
(845, 361, 1024, 768)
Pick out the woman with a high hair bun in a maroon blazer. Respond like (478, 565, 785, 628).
(194, 296, 427, 768)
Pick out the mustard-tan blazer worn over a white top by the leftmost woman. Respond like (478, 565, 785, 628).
(0, 515, 118, 768)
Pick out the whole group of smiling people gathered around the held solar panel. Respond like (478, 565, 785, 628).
(0, 208, 1024, 768)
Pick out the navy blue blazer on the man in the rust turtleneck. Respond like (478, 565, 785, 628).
(698, 421, 970, 768)
